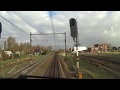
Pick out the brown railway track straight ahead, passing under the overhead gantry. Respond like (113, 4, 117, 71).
(45, 53, 75, 79)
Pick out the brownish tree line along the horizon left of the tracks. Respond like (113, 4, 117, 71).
(2, 36, 51, 60)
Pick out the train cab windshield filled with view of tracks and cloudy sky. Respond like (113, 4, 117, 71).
(0, 11, 120, 79)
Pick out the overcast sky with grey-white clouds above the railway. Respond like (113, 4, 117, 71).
(0, 11, 120, 48)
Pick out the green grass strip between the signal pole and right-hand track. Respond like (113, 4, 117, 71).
(79, 60, 115, 79)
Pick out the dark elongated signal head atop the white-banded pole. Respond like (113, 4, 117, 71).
(69, 18, 78, 38)
